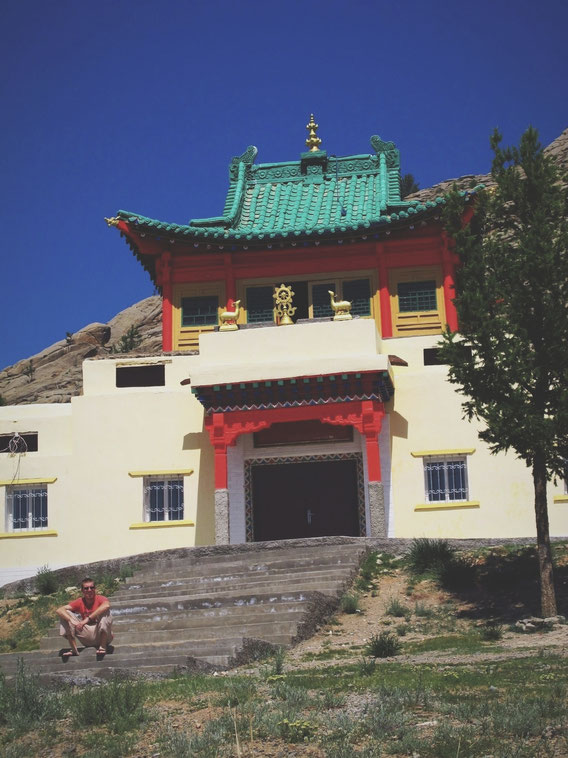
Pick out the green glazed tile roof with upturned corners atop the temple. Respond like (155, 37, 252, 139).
(117, 136, 478, 242)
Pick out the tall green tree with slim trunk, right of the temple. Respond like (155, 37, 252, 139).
(441, 127, 568, 616)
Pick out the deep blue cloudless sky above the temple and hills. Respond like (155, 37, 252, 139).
(0, 0, 568, 368)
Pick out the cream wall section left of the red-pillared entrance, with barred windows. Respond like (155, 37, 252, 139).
(0, 356, 214, 583)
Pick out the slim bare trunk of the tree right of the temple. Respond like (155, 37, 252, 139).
(532, 453, 556, 618)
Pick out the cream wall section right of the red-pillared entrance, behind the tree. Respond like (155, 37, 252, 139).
(383, 336, 568, 538)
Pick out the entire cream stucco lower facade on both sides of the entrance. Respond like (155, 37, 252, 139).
(0, 319, 568, 584)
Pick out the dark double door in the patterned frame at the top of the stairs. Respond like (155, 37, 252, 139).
(251, 460, 360, 542)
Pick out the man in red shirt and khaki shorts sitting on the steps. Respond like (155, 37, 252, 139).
(56, 576, 113, 658)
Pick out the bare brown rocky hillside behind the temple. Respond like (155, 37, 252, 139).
(0, 129, 568, 405)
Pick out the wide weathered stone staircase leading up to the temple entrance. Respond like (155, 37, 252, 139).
(0, 537, 366, 682)
